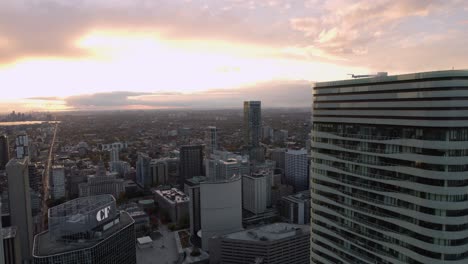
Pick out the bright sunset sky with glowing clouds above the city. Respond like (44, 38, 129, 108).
(0, 0, 468, 112)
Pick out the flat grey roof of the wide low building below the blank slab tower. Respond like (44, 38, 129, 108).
(224, 223, 310, 242)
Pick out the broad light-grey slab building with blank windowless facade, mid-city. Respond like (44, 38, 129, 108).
(200, 175, 242, 251)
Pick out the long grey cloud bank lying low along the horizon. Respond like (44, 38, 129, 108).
(64, 81, 312, 110)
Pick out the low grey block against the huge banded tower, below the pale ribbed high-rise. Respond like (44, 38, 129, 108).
(279, 190, 310, 225)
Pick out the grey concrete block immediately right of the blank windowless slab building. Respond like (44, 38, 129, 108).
(242, 170, 272, 214)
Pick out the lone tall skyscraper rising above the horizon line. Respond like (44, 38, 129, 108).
(243, 101, 262, 147)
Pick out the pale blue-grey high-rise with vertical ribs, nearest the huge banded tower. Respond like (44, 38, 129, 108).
(284, 149, 309, 192)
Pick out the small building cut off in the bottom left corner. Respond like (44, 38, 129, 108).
(1, 226, 21, 264)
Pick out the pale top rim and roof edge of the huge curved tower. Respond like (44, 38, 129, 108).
(315, 70, 468, 88)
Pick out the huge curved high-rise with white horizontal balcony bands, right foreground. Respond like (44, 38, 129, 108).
(311, 70, 468, 264)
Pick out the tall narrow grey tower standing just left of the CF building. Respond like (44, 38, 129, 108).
(6, 158, 33, 261)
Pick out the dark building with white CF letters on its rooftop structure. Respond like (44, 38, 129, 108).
(33, 195, 136, 264)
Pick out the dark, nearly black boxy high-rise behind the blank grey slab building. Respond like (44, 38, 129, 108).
(179, 145, 205, 188)
